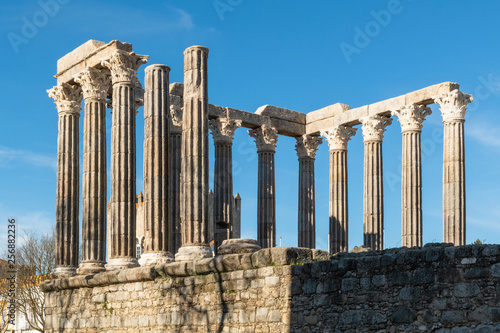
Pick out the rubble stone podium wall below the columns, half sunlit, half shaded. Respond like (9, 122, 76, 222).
(42, 244, 500, 333)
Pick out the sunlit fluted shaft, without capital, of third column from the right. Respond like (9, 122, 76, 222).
(363, 141, 384, 250)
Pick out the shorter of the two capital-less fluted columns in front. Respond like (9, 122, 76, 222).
(139, 65, 174, 266)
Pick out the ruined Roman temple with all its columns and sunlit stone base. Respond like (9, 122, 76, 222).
(42, 40, 496, 332)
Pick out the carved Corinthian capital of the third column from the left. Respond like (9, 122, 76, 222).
(101, 50, 149, 84)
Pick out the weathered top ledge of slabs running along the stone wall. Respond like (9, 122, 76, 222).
(40, 243, 500, 292)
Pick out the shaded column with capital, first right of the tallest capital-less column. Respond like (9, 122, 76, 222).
(209, 117, 241, 249)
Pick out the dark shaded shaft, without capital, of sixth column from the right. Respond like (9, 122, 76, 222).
(257, 151, 276, 248)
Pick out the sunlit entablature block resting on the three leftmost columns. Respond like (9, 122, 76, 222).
(55, 39, 132, 85)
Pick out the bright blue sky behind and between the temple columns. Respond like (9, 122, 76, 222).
(0, 0, 500, 249)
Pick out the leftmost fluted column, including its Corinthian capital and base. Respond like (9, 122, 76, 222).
(47, 83, 82, 277)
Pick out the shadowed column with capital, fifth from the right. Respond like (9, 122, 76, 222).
(295, 134, 323, 249)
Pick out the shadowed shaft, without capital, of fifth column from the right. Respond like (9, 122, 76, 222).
(298, 157, 316, 249)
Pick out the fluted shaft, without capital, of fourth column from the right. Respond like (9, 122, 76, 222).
(329, 149, 349, 253)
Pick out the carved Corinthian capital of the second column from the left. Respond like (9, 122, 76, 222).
(73, 67, 110, 102)
